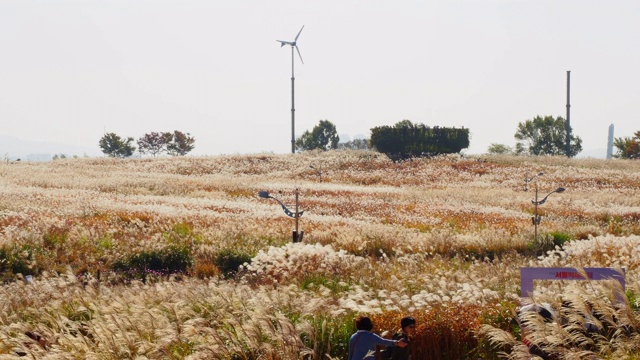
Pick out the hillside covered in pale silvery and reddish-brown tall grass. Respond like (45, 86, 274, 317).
(0, 152, 640, 359)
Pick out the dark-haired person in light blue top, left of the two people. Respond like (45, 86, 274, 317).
(349, 316, 407, 360)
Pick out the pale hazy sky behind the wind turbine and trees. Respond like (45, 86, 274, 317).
(0, 0, 640, 156)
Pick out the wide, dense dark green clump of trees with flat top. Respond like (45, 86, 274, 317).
(371, 120, 469, 160)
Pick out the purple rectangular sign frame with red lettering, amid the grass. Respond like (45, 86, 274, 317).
(520, 268, 625, 298)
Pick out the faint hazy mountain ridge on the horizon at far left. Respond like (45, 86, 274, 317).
(0, 134, 102, 161)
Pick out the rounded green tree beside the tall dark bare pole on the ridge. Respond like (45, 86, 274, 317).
(514, 115, 582, 157)
